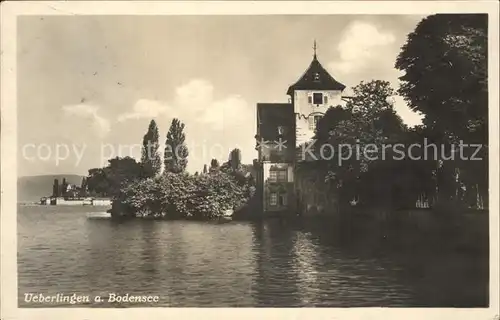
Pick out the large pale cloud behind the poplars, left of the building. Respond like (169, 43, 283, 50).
(118, 79, 255, 172)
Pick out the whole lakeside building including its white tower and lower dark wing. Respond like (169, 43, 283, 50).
(254, 42, 345, 214)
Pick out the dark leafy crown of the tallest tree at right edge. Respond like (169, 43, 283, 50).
(396, 14, 488, 138)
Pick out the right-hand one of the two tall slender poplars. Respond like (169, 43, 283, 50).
(164, 118, 189, 173)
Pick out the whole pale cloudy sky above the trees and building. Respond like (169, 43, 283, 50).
(17, 15, 423, 176)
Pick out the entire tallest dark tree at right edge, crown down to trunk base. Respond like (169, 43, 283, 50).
(396, 14, 488, 210)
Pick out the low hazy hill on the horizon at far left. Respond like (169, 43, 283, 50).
(17, 174, 84, 202)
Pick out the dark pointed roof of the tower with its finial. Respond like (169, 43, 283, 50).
(286, 41, 345, 95)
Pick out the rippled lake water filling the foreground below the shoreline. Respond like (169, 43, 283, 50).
(18, 206, 488, 307)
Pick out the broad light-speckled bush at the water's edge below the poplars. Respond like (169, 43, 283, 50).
(116, 171, 254, 219)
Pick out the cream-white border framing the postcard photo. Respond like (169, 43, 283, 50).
(0, 1, 500, 320)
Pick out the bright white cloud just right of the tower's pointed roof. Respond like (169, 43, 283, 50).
(330, 21, 396, 73)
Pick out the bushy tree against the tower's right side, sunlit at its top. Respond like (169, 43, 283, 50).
(314, 80, 406, 205)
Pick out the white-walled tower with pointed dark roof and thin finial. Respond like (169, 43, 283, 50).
(287, 41, 345, 147)
